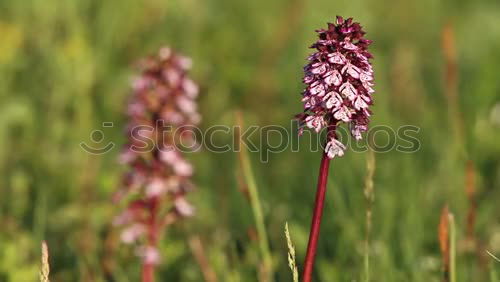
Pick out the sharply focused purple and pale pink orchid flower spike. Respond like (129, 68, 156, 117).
(298, 16, 375, 159)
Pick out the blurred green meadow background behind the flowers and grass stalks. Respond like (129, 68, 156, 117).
(0, 0, 500, 282)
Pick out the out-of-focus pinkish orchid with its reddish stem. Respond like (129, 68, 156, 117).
(114, 47, 200, 282)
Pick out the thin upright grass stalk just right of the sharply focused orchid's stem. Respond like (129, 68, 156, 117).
(364, 151, 375, 282)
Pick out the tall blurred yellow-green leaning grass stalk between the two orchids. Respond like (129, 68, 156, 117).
(236, 111, 272, 281)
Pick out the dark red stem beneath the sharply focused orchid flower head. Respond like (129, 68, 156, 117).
(302, 152, 330, 282)
